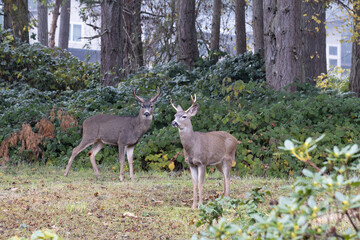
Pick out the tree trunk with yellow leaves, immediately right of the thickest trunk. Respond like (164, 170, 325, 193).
(301, 0, 327, 85)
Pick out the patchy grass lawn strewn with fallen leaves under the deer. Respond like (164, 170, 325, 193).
(0, 165, 289, 239)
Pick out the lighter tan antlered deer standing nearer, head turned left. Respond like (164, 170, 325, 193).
(170, 95, 239, 208)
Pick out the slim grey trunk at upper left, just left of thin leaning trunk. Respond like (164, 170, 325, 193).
(37, 0, 49, 46)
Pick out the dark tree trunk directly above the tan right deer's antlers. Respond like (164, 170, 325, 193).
(178, 0, 199, 68)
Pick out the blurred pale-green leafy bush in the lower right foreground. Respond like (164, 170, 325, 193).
(192, 138, 360, 240)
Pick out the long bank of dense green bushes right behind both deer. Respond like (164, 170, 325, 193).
(0, 33, 360, 176)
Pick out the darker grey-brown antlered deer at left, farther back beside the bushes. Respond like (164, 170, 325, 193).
(64, 88, 160, 182)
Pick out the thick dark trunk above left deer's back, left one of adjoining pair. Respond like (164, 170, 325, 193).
(101, 0, 123, 86)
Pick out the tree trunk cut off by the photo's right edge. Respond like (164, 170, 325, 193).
(349, 2, 360, 97)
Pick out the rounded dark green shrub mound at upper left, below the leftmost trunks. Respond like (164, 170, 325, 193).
(0, 28, 100, 91)
